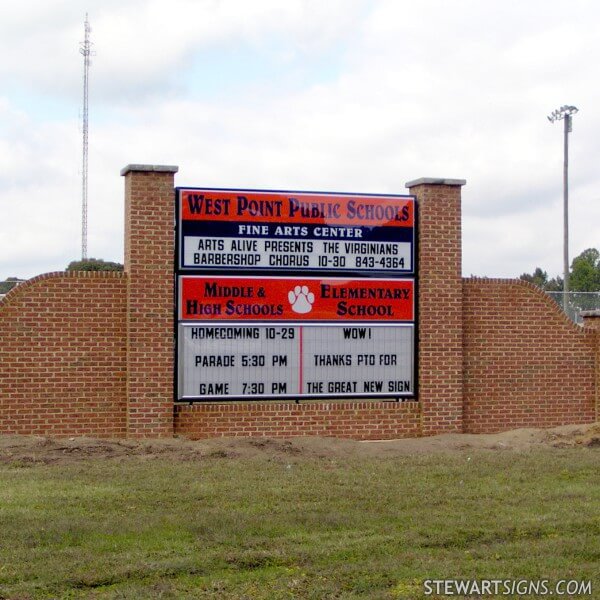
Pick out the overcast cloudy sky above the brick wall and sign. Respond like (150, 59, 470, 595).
(0, 0, 600, 279)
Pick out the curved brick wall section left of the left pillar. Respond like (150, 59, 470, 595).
(0, 272, 126, 437)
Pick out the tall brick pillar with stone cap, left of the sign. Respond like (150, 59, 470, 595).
(121, 165, 178, 437)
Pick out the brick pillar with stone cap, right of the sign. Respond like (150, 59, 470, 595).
(406, 177, 466, 435)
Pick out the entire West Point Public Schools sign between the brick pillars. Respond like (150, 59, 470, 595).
(177, 189, 416, 400)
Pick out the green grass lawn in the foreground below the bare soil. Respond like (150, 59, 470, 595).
(0, 449, 600, 600)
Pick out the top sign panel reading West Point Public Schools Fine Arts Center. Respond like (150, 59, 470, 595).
(177, 188, 416, 276)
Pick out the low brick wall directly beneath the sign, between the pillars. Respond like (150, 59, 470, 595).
(175, 401, 421, 440)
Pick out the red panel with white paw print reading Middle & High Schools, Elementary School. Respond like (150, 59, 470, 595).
(179, 275, 415, 322)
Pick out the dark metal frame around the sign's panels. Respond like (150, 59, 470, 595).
(173, 186, 419, 404)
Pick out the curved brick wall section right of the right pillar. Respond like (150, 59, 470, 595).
(464, 279, 597, 433)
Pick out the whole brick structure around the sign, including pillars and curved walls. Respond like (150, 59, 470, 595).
(0, 165, 600, 439)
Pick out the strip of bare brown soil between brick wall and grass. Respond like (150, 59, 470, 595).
(0, 422, 600, 466)
